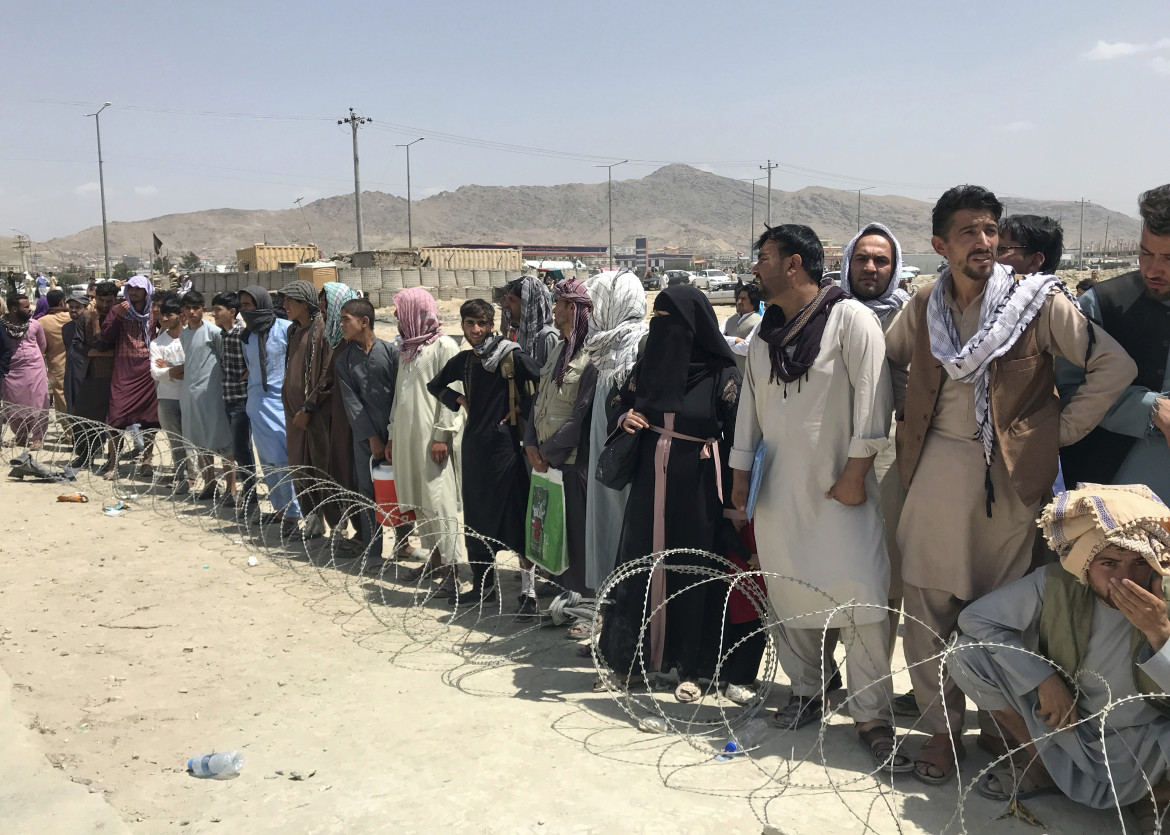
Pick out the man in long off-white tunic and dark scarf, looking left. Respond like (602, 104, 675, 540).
(730, 225, 911, 771)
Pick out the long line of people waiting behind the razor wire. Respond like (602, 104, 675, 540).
(0, 185, 1170, 831)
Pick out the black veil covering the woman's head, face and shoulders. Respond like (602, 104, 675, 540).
(634, 284, 735, 414)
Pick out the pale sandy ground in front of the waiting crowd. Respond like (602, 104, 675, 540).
(0, 430, 1137, 835)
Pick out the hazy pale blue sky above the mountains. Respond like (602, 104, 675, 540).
(0, 0, 1170, 240)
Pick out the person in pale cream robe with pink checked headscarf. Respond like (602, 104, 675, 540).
(386, 288, 467, 594)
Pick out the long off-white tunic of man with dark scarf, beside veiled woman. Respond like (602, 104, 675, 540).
(731, 299, 893, 629)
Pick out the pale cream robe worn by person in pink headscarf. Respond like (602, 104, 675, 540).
(387, 336, 466, 565)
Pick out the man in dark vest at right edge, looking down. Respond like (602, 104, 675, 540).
(1058, 184, 1170, 502)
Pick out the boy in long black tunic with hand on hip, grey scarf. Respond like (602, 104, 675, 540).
(427, 297, 544, 605)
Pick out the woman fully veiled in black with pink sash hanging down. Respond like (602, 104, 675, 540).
(599, 285, 741, 702)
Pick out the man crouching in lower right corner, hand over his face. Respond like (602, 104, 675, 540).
(949, 484, 1170, 833)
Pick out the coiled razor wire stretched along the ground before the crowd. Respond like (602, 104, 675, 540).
(0, 403, 1166, 834)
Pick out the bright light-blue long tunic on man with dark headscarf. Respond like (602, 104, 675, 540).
(243, 319, 301, 519)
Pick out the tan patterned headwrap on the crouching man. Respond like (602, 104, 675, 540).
(1040, 484, 1170, 584)
